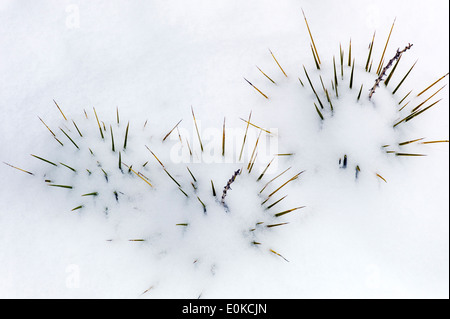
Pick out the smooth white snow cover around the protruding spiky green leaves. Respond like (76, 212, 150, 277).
(0, 0, 449, 298)
